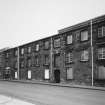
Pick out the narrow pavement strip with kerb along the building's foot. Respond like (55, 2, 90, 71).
(3, 80, 105, 91)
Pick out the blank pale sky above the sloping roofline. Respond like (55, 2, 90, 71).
(0, 0, 105, 49)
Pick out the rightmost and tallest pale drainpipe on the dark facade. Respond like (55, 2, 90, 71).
(90, 20, 94, 86)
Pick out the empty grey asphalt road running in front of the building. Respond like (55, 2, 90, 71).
(0, 81, 105, 105)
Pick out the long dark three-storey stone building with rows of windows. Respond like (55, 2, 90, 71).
(0, 15, 105, 85)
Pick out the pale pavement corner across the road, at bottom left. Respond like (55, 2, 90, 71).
(0, 95, 35, 105)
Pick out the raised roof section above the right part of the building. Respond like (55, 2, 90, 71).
(58, 15, 105, 34)
